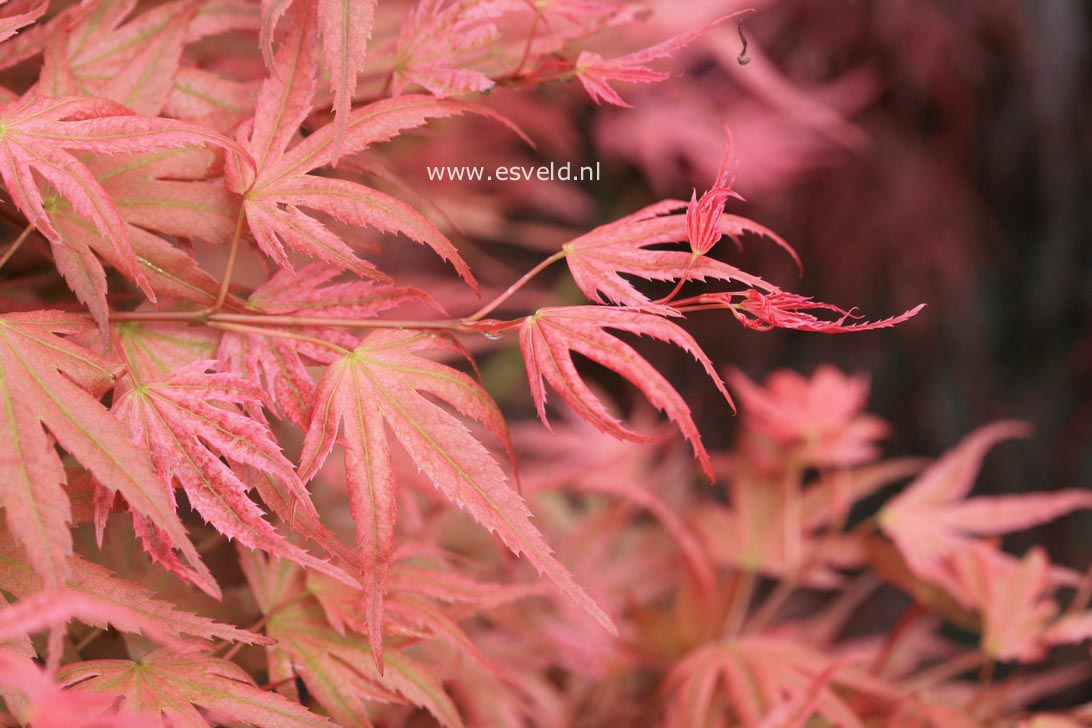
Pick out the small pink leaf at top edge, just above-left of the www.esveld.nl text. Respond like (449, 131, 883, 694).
(391, 0, 510, 98)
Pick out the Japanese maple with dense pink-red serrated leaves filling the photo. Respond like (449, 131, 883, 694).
(0, 0, 1092, 728)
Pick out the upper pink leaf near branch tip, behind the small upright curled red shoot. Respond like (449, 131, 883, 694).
(561, 200, 791, 307)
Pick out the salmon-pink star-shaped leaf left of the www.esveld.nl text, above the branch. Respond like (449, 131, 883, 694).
(227, 12, 504, 289)
